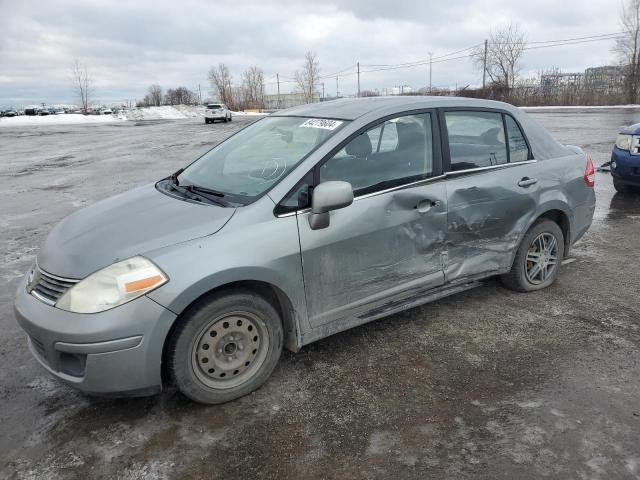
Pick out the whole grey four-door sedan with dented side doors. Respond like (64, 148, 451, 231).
(15, 97, 595, 403)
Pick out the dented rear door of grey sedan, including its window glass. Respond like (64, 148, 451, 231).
(440, 109, 540, 281)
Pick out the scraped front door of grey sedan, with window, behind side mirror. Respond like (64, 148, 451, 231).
(298, 111, 447, 327)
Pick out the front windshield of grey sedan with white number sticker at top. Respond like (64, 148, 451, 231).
(178, 117, 346, 203)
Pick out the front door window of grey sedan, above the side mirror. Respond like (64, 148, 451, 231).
(320, 113, 433, 195)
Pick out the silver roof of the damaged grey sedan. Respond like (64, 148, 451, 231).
(273, 96, 514, 120)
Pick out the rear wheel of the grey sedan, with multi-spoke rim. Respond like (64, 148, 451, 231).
(501, 220, 564, 292)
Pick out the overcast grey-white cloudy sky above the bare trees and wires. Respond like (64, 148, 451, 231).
(0, 0, 620, 105)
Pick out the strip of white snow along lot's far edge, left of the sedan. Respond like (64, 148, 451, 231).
(0, 105, 265, 127)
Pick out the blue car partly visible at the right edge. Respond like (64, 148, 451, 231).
(611, 123, 640, 193)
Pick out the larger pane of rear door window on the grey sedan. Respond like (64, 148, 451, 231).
(444, 111, 508, 171)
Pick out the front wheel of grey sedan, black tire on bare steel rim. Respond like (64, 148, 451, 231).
(167, 290, 283, 404)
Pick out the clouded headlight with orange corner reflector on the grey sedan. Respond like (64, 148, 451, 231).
(56, 257, 168, 313)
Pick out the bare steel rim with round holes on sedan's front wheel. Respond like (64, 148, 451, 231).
(191, 311, 270, 389)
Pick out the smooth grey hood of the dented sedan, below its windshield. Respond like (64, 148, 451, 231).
(37, 185, 235, 279)
